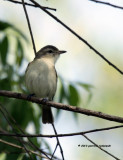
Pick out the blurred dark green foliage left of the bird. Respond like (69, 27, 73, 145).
(0, 21, 41, 160)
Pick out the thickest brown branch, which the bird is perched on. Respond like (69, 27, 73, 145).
(0, 90, 123, 123)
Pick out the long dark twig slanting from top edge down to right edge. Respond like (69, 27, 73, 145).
(30, 0, 123, 74)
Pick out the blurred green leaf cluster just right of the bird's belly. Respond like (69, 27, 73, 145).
(56, 77, 93, 120)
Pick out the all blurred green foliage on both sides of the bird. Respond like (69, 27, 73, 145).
(0, 21, 93, 160)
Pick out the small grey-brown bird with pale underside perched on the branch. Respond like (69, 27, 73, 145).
(25, 45, 66, 123)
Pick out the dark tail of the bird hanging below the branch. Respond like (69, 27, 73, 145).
(42, 105, 54, 123)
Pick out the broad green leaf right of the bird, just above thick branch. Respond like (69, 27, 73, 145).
(68, 84, 79, 106)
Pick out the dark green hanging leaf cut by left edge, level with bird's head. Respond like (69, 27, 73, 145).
(0, 36, 9, 65)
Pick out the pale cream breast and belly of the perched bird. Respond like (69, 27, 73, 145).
(26, 59, 57, 99)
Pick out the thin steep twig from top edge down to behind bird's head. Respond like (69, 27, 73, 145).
(22, 0, 36, 56)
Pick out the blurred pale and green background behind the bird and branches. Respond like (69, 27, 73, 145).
(0, 0, 123, 160)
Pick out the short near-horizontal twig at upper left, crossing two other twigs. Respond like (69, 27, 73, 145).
(4, 0, 56, 11)
